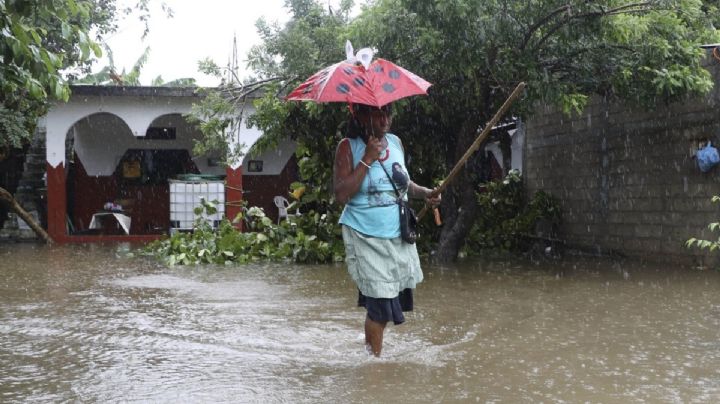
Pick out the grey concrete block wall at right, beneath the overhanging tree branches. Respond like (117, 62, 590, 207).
(523, 68, 720, 265)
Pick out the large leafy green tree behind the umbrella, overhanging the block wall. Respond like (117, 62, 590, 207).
(202, 0, 720, 261)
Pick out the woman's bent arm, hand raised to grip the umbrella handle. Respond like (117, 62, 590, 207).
(333, 137, 381, 204)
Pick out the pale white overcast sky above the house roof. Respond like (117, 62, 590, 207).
(94, 0, 290, 86)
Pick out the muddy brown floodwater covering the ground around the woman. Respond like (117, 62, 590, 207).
(0, 244, 720, 403)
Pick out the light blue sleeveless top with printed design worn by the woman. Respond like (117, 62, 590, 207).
(340, 133, 410, 238)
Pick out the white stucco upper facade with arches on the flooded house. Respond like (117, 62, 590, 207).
(41, 90, 294, 175)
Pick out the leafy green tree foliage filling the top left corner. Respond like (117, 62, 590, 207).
(0, 0, 172, 149)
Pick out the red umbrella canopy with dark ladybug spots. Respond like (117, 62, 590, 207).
(286, 59, 431, 107)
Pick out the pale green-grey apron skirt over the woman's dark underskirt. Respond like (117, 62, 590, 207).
(342, 225, 423, 299)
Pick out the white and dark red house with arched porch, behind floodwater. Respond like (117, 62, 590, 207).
(40, 86, 297, 243)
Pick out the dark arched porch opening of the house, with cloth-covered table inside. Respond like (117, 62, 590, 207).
(65, 112, 225, 236)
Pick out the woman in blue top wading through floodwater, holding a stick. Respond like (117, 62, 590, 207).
(334, 104, 440, 356)
